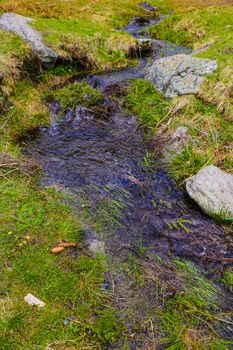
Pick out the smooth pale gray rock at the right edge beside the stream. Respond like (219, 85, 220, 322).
(186, 165, 233, 218)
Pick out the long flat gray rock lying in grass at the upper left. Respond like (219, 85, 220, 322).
(0, 13, 59, 66)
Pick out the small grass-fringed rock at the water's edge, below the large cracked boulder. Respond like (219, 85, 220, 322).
(163, 126, 191, 162)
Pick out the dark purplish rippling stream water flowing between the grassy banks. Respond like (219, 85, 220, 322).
(25, 4, 233, 349)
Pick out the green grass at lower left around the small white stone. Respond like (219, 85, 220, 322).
(0, 177, 123, 350)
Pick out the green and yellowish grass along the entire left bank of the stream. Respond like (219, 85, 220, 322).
(0, 2, 160, 350)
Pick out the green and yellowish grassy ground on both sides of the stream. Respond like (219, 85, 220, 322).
(0, 0, 232, 350)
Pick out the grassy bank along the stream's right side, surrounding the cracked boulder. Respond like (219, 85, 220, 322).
(125, 1, 233, 184)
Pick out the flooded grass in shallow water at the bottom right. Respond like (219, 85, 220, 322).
(112, 251, 232, 350)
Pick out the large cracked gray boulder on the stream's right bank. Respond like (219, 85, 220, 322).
(147, 54, 218, 97)
